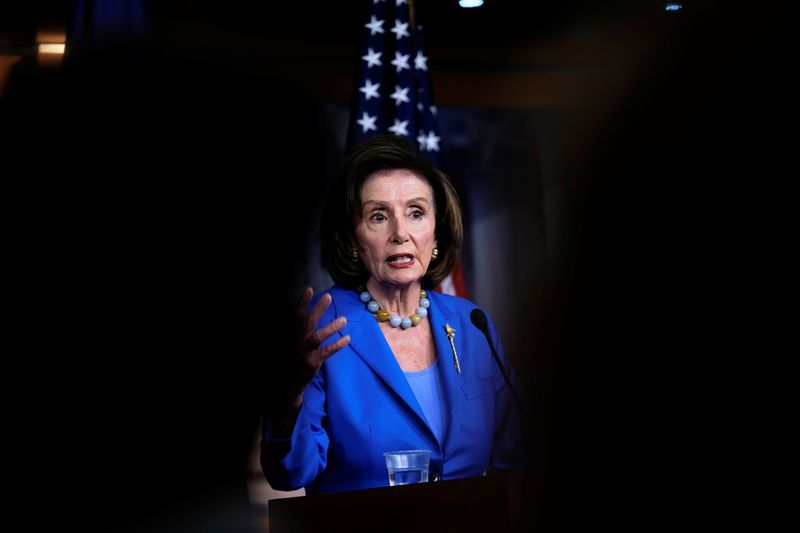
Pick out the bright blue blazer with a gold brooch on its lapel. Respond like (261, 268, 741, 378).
(262, 286, 523, 494)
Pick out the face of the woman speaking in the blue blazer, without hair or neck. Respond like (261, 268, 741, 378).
(355, 170, 436, 286)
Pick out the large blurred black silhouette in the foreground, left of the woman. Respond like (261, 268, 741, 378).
(2, 52, 319, 531)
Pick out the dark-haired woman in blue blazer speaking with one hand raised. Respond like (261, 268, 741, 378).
(261, 135, 522, 494)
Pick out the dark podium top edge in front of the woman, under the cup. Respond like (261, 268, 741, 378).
(269, 474, 524, 533)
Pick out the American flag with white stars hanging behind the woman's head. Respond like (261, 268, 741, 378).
(348, 0, 466, 296)
